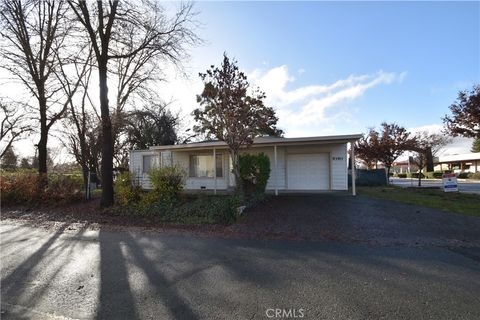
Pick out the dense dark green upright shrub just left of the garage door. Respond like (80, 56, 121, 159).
(239, 153, 270, 195)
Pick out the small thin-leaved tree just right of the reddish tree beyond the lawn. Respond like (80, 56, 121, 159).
(412, 131, 450, 187)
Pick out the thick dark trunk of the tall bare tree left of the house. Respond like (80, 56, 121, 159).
(98, 58, 114, 207)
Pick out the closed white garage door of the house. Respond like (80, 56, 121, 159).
(287, 153, 330, 190)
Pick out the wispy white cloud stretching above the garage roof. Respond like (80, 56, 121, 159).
(249, 65, 407, 136)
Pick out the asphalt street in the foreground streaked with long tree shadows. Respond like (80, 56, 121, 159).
(0, 220, 480, 319)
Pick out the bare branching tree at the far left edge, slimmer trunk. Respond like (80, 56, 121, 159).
(0, 0, 69, 183)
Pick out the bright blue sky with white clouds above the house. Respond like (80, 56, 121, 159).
(3, 1, 480, 160)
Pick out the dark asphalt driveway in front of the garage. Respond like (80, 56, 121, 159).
(231, 193, 480, 247)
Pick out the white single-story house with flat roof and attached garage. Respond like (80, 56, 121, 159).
(130, 134, 361, 194)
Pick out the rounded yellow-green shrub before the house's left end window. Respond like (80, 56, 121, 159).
(148, 166, 186, 202)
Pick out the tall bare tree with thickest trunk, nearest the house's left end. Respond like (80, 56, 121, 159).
(68, 0, 198, 207)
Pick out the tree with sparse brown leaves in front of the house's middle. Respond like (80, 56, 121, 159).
(193, 54, 281, 192)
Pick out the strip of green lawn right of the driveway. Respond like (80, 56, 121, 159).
(358, 186, 480, 217)
